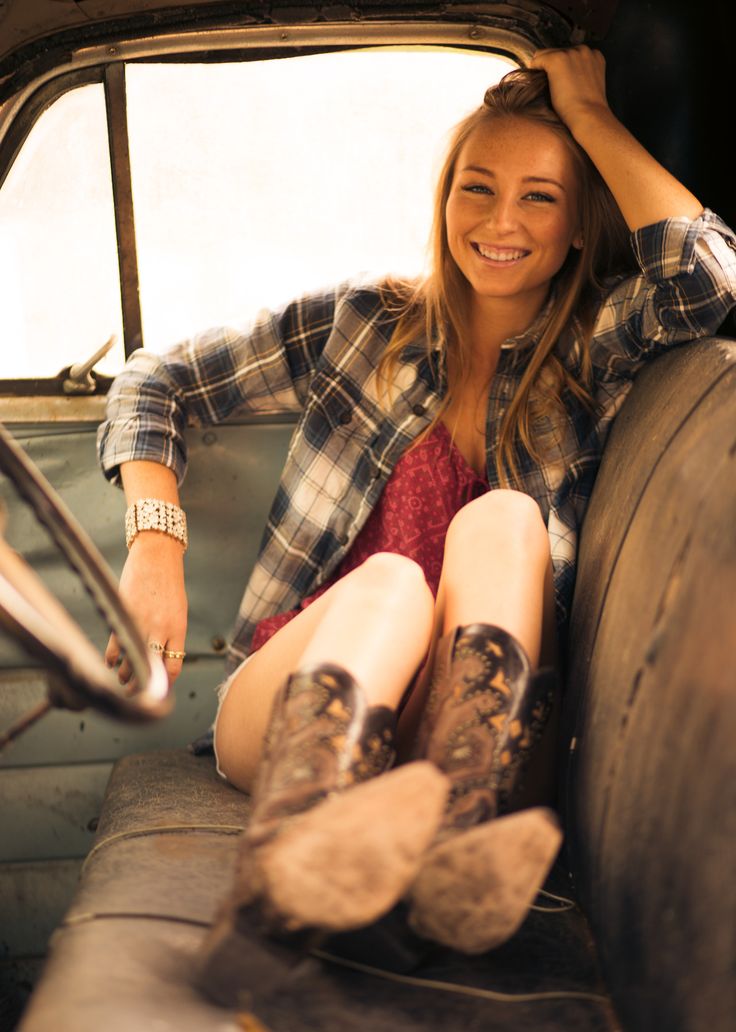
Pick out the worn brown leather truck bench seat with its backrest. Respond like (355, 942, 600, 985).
(21, 340, 736, 1032)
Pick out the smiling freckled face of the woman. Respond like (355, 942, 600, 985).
(445, 117, 582, 317)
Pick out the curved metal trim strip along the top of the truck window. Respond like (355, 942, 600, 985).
(0, 22, 535, 144)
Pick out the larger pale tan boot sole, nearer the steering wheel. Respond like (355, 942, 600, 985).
(258, 761, 449, 932)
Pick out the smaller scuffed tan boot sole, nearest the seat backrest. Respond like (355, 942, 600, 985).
(409, 807, 563, 954)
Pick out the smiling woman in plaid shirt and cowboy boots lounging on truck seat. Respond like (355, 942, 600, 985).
(100, 46, 736, 968)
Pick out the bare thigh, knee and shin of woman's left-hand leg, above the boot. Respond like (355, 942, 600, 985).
(216, 552, 433, 791)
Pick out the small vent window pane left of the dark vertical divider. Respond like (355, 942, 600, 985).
(0, 84, 123, 379)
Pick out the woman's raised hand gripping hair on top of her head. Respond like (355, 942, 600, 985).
(530, 46, 610, 135)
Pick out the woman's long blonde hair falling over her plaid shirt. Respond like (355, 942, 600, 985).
(378, 69, 634, 486)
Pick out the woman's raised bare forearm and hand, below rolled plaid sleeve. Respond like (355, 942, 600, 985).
(531, 46, 703, 231)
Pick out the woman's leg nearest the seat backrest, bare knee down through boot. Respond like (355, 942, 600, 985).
(396, 491, 561, 953)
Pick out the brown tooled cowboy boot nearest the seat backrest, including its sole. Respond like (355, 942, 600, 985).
(409, 623, 562, 954)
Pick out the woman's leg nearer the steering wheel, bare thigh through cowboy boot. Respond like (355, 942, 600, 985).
(200, 553, 449, 990)
